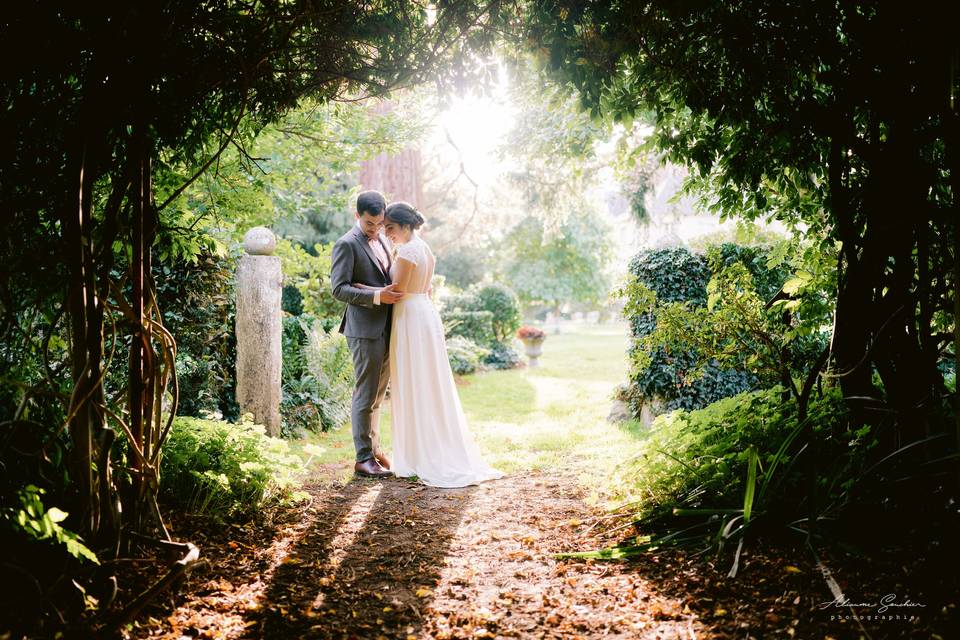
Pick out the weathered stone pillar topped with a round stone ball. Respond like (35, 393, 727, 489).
(237, 227, 283, 436)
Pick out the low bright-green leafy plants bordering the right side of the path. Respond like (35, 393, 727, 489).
(600, 387, 884, 577)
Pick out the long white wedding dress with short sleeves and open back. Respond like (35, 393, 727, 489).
(390, 235, 503, 487)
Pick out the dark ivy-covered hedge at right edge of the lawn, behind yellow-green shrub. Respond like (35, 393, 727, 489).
(625, 243, 787, 416)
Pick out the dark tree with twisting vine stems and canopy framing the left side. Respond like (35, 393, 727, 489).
(0, 0, 512, 622)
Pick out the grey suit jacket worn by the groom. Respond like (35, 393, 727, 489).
(330, 225, 393, 338)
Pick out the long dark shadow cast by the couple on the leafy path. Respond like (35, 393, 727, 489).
(246, 479, 476, 638)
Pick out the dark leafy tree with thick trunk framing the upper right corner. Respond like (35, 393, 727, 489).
(528, 0, 960, 448)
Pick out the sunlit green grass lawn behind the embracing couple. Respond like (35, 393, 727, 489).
(297, 324, 637, 498)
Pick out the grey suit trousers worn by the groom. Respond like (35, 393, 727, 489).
(347, 333, 390, 462)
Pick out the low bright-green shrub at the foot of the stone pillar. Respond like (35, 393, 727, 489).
(160, 417, 303, 518)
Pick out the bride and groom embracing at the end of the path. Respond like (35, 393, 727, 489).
(330, 191, 503, 487)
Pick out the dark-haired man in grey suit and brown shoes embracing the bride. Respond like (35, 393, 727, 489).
(330, 191, 403, 478)
